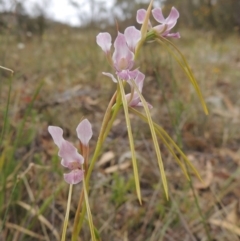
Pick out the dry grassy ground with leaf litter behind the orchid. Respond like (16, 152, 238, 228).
(0, 25, 240, 241)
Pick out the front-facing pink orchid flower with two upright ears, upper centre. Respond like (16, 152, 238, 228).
(96, 26, 141, 82)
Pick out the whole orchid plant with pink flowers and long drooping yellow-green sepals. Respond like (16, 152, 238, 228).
(48, 1, 208, 241)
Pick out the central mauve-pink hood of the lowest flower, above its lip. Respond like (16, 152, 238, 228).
(58, 140, 84, 168)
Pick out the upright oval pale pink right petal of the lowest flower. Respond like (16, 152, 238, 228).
(76, 119, 92, 146)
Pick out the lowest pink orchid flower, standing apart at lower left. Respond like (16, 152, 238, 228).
(48, 119, 92, 184)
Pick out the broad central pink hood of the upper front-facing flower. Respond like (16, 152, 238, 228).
(112, 33, 134, 71)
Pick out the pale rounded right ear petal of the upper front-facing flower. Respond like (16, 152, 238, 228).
(124, 26, 141, 52)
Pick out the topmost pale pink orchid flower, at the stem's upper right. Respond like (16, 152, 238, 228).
(137, 7, 180, 38)
